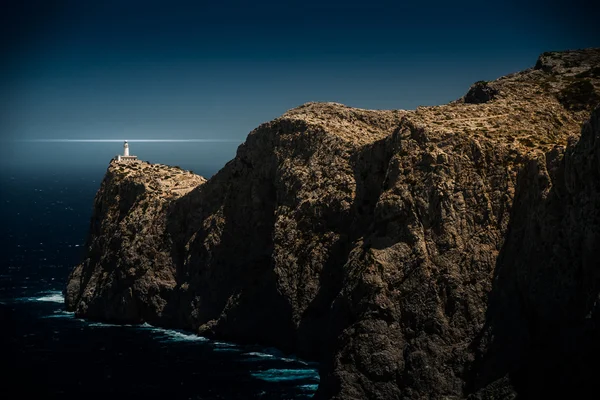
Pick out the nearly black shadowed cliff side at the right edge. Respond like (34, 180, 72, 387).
(472, 104, 600, 398)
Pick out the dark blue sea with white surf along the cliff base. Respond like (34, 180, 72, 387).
(0, 170, 319, 399)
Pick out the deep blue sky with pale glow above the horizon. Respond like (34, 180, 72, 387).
(0, 0, 600, 175)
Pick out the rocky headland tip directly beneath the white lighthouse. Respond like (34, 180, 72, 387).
(65, 161, 205, 325)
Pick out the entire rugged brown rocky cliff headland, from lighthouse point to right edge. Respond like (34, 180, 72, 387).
(66, 50, 600, 399)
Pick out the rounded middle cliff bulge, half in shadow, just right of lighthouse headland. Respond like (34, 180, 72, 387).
(164, 104, 402, 358)
